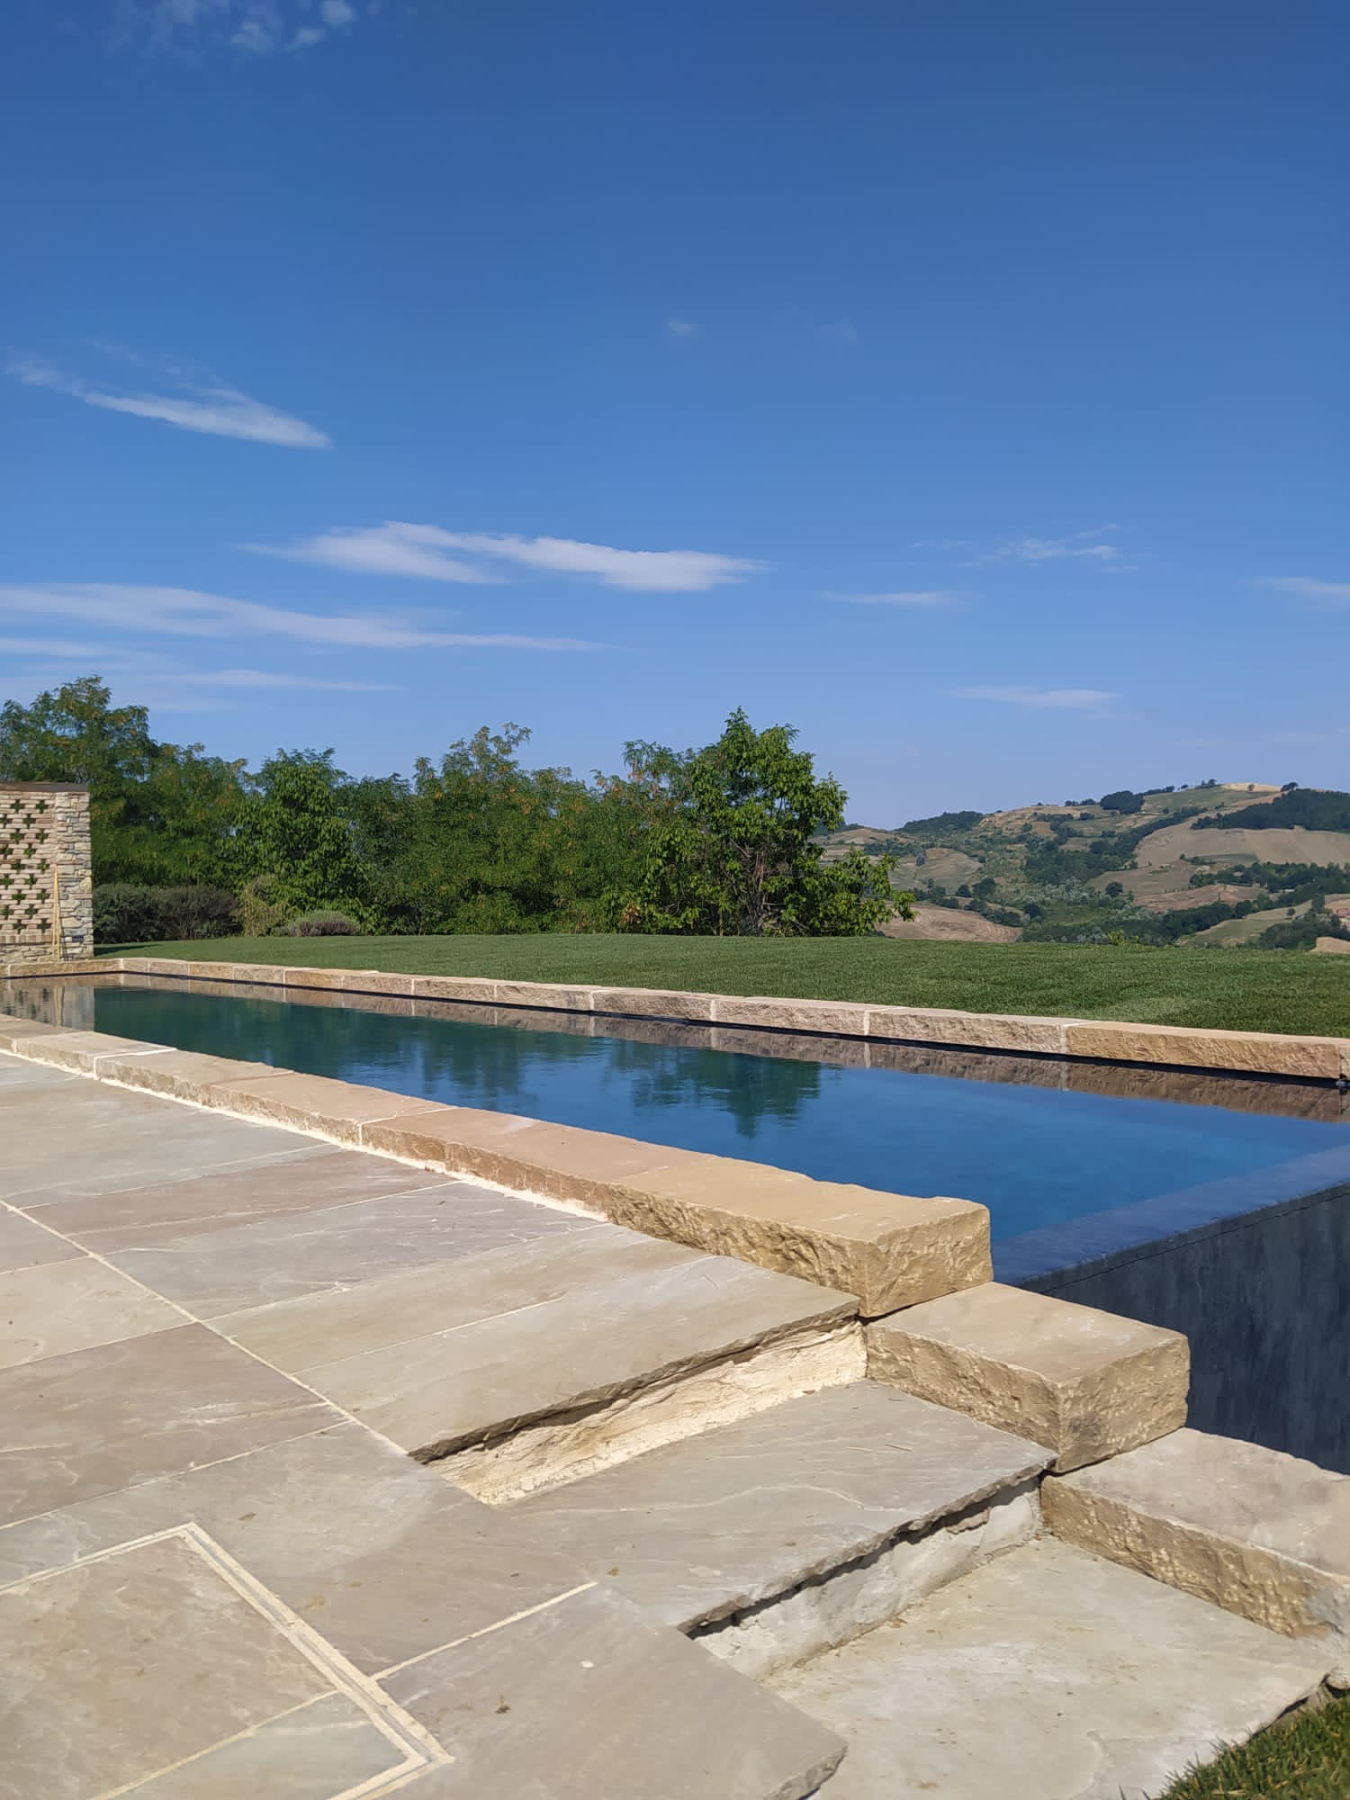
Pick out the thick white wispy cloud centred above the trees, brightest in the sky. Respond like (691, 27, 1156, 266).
(243, 520, 765, 594)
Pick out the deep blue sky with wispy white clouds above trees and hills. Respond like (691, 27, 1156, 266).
(0, 0, 1350, 824)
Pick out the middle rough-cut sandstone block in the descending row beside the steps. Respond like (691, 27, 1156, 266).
(868, 1282, 1190, 1469)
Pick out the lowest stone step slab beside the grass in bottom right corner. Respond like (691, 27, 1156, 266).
(767, 1539, 1327, 1800)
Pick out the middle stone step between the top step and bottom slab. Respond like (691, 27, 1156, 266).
(511, 1381, 1049, 1676)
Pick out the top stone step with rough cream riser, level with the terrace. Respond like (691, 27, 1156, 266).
(212, 1220, 866, 1503)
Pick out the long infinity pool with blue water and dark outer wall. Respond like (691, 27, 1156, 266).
(10, 976, 1350, 1472)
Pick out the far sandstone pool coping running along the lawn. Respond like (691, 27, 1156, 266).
(10, 956, 1350, 1082)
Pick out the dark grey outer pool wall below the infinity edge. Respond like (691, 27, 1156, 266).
(1026, 1195, 1350, 1474)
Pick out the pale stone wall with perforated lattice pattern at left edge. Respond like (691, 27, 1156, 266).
(0, 781, 94, 965)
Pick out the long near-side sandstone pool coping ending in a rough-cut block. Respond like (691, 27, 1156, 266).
(0, 1015, 992, 1318)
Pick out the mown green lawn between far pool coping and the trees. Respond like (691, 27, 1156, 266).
(108, 936, 1350, 1037)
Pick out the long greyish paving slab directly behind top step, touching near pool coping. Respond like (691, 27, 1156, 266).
(104, 1170, 589, 1319)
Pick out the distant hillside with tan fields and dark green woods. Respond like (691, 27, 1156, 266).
(824, 781, 1350, 950)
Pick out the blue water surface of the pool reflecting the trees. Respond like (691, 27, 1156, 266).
(60, 985, 1350, 1280)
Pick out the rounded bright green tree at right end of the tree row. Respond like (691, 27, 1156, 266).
(621, 709, 914, 938)
